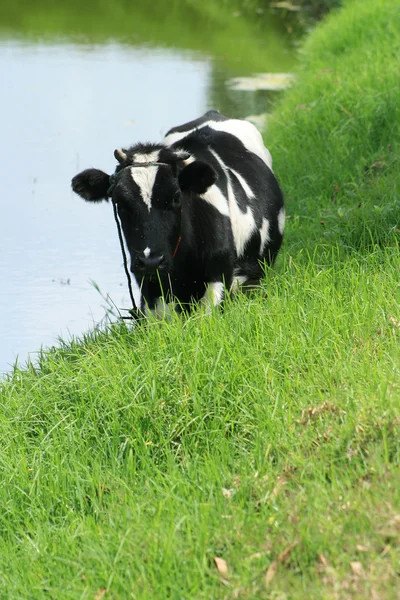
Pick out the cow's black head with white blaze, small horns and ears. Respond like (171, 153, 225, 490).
(72, 144, 217, 279)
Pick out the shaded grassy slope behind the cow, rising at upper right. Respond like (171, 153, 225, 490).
(266, 0, 400, 250)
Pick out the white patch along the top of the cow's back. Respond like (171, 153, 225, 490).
(162, 119, 272, 171)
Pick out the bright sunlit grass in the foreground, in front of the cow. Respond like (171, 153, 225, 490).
(0, 248, 400, 598)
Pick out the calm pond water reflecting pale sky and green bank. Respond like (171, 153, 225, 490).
(0, 0, 294, 372)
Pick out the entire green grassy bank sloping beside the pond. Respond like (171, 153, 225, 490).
(0, 0, 400, 600)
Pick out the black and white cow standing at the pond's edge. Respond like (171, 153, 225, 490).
(72, 111, 285, 312)
